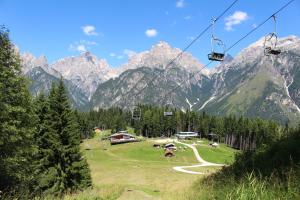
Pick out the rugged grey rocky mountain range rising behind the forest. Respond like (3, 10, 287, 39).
(21, 36, 300, 124)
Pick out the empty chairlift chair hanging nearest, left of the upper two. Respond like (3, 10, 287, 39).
(207, 18, 225, 61)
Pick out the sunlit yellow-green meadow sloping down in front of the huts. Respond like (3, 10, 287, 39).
(67, 132, 234, 199)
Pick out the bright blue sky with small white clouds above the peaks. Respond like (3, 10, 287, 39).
(0, 0, 300, 66)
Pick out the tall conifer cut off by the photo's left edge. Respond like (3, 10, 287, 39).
(0, 27, 34, 192)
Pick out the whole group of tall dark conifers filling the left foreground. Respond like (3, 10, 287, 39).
(0, 27, 92, 199)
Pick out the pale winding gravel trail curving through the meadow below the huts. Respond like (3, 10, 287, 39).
(173, 140, 225, 174)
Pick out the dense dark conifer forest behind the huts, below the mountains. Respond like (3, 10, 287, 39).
(81, 105, 290, 150)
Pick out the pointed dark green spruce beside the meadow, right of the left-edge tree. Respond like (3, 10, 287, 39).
(36, 80, 91, 195)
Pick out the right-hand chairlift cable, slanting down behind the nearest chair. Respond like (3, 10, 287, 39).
(161, 0, 295, 106)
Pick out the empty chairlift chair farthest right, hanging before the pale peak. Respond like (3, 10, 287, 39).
(264, 15, 281, 56)
